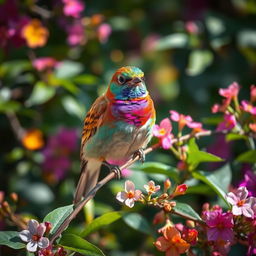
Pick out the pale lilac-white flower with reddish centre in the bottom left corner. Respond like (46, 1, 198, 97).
(19, 219, 49, 252)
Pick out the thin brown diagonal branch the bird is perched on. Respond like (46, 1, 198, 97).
(50, 130, 236, 244)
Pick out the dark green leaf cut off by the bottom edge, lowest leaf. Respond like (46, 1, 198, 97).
(59, 234, 105, 256)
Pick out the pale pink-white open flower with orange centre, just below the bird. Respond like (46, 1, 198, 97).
(116, 180, 142, 208)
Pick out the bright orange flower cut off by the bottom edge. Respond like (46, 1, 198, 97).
(155, 225, 190, 256)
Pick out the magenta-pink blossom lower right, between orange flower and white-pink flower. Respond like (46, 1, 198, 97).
(204, 210, 234, 241)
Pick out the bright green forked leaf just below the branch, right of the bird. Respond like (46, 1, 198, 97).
(187, 138, 223, 170)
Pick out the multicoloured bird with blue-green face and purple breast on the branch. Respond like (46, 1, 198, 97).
(73, 66, 156, 205)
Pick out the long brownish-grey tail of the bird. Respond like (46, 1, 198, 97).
(73, 159, 102, 205)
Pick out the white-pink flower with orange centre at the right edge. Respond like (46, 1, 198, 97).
(226, 186, 254, 218)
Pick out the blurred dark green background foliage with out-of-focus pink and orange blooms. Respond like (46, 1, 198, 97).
(0, 0, 256, 255)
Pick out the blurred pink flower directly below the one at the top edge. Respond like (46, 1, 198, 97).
(67, 22, 86, 46)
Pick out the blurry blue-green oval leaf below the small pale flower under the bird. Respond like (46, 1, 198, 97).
(123, 213, 152, 235)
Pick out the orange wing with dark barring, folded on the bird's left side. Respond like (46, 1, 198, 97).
(81, 95, 108, 155)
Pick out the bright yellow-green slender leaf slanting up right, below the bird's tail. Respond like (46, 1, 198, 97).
(80, 212, 122, 237)
